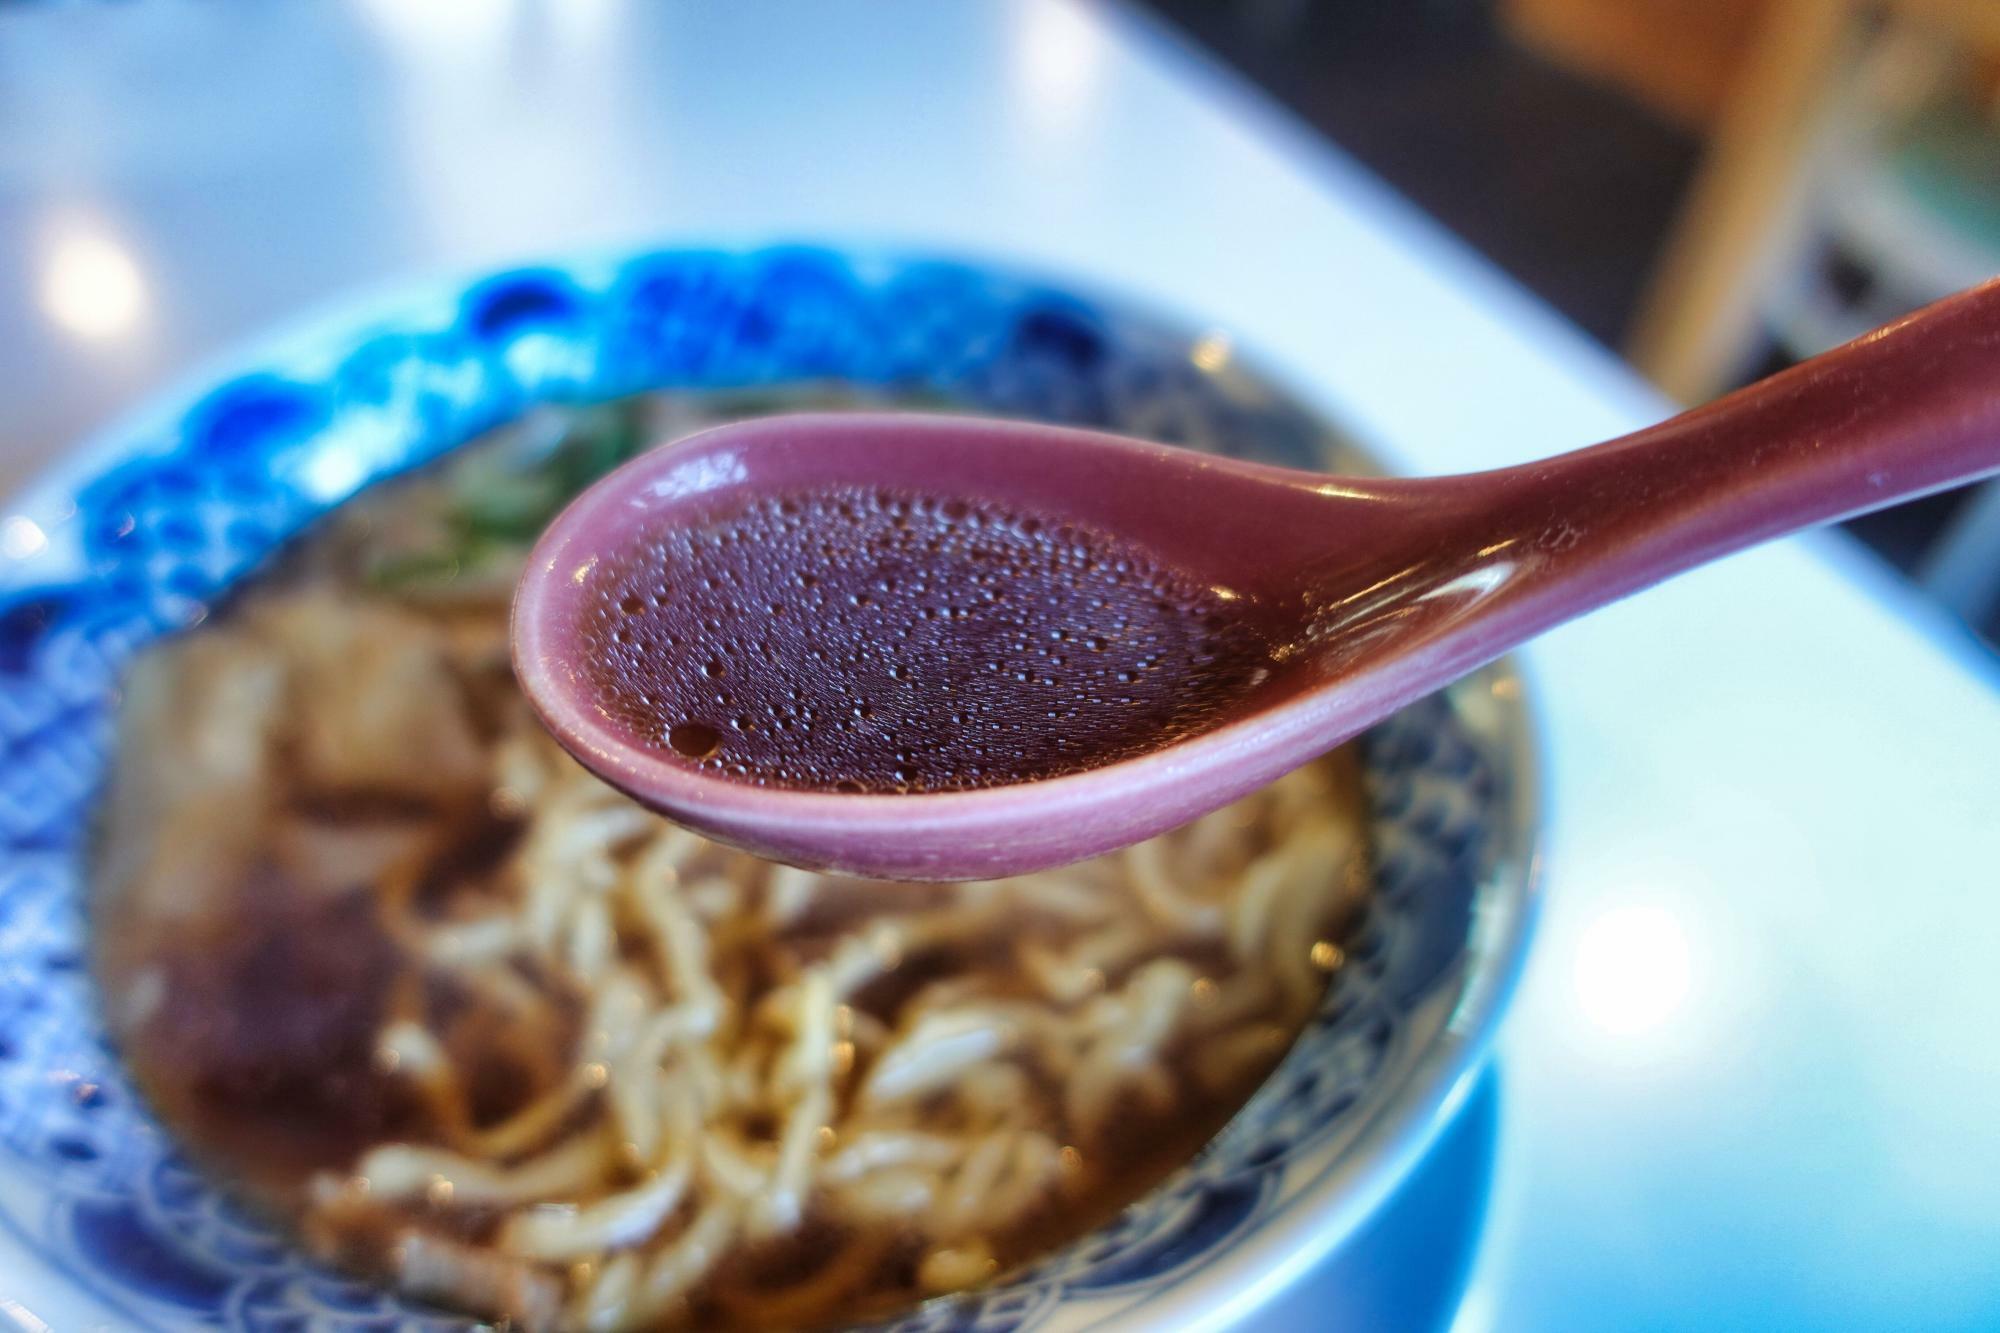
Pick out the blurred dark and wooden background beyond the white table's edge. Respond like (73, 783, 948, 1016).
(1150, 0, 2000, 646)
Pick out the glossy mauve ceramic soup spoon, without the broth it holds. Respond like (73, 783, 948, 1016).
(514, 282, 2000, 879)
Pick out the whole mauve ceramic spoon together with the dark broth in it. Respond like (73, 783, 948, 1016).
(514, 282, 2000, 879)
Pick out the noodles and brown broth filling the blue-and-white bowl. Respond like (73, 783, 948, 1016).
(94, 396, 1368, 1329)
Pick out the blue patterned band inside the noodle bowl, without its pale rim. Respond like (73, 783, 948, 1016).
(0, 248, 1502, 1333)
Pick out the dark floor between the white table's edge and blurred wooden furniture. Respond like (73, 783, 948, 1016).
(1152, 0, 1702, 346)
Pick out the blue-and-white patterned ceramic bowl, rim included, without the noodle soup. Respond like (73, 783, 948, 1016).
(0, 246, 1534, 1333)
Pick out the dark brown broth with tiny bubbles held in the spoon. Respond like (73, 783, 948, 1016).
(584, 486, 1272, 791)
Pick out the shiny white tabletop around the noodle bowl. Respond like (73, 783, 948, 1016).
(0, 0, 2000, 1333)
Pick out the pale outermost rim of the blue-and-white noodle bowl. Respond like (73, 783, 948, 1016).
(0, 241, 1548, 1329)
